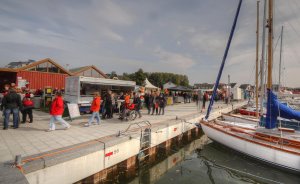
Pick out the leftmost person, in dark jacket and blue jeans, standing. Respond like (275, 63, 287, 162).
(1, 88, 22, 130)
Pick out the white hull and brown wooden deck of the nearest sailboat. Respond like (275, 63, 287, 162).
(201, 120, 300, 172)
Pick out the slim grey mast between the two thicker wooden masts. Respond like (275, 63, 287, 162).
(260, 0, 267, 114)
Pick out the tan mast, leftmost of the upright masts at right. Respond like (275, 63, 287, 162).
(255, 1, 259, 117)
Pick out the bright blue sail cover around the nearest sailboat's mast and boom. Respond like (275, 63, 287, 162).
(265, 89, 300, 129)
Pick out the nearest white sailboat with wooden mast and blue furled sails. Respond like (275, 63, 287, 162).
(200, 0, 300, 172)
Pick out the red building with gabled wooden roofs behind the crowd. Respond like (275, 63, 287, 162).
(0, 58, 107, 90)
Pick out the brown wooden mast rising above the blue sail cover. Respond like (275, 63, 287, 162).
(267, 0, 273, 90)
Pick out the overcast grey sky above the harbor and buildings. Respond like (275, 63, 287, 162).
(0, 0, 300, 87)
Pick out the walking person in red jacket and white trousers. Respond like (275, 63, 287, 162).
(47, 91, 71, 132)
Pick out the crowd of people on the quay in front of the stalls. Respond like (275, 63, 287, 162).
(0, 83, 166, 132)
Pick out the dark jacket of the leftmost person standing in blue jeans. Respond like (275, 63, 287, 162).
(2, 90, 22, 109)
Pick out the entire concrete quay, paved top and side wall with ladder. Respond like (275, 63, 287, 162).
(0, 102, 246, 183)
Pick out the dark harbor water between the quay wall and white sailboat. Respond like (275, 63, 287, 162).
(129, 133, 300, 184)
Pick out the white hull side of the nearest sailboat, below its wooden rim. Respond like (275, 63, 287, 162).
(201, 123, 300, 172)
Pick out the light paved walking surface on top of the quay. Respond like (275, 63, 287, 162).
(0, 103, 241, 163)
